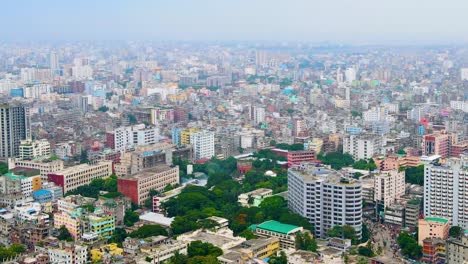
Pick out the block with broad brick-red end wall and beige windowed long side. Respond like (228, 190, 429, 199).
(118, 165, 179, 204)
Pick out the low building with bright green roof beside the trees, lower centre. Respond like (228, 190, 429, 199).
(249, 220, 304, 249)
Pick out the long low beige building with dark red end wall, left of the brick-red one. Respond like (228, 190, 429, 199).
(47, 161, 112, 194)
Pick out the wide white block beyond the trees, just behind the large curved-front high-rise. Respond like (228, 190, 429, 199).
(343, 134, 383, 160)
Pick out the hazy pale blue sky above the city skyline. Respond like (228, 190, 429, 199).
(0, 0, 468, 44)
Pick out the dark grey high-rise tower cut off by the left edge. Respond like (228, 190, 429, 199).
(0, 104, 30, 158)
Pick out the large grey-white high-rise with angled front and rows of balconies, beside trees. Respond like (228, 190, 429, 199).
(288, 164, 362, 237)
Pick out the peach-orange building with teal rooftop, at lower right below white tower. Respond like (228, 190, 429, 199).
(418, 217, 450, 245)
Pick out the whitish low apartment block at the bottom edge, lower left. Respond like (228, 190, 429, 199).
(47, 245, 88, 264)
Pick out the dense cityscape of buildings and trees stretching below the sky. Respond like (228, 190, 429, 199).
(0, 1, 468, 264)
